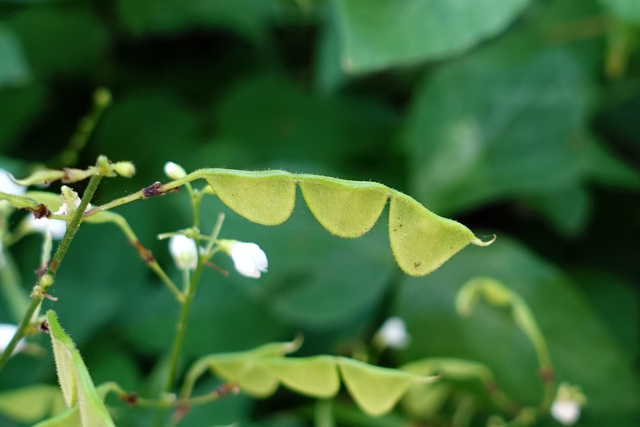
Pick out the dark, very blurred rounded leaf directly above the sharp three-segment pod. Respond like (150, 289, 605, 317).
(215, 75, 397, 174)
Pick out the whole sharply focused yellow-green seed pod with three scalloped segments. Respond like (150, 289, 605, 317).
(200, 169, 488, 276)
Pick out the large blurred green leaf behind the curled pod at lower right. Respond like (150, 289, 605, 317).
(395, 237, 640, 427)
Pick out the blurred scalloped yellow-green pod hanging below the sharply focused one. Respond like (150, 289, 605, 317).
(182, 343, 435, 416)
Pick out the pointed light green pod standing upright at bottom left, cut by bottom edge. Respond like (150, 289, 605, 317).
(47, 310, 115, 427)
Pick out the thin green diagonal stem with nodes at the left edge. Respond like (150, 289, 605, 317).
(0, 172, 106, 370)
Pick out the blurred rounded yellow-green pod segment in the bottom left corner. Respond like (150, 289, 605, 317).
(0, 384, 64, 423)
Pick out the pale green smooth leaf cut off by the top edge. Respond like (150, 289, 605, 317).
(335, 0, 529, 72)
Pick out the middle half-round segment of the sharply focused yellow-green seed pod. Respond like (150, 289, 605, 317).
(300, 178, 389, 237)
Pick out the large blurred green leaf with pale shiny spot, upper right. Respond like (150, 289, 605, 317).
(406, 35, 587, 217)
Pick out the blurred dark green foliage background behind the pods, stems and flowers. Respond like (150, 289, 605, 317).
(0, 0, 640, 426)
